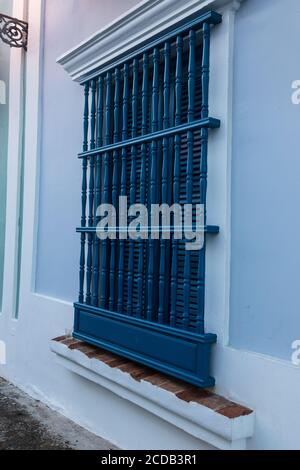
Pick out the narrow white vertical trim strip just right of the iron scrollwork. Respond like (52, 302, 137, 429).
(20, 0, 45, 305)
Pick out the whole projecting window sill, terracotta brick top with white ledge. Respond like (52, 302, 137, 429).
(51, 336, 254, 449)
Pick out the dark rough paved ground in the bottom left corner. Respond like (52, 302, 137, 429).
(0, 378, 115, 450)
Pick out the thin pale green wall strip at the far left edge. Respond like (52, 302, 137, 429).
(0, 0, 12, 310)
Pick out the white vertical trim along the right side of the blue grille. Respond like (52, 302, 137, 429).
(205, 0, 241, 348)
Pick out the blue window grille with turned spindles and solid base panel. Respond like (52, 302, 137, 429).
(74, 12, 222, 387)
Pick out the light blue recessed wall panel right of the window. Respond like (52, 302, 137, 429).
(230, 0, 300, 359)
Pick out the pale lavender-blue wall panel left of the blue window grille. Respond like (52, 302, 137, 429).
(36, 0, 138, 301)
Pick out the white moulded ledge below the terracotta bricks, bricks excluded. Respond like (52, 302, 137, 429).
(51, 341, 254, 450)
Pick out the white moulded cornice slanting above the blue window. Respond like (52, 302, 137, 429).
(57, 0, 242, 83)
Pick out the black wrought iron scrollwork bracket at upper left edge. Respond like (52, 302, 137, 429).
(0, 13, 28, 51)
